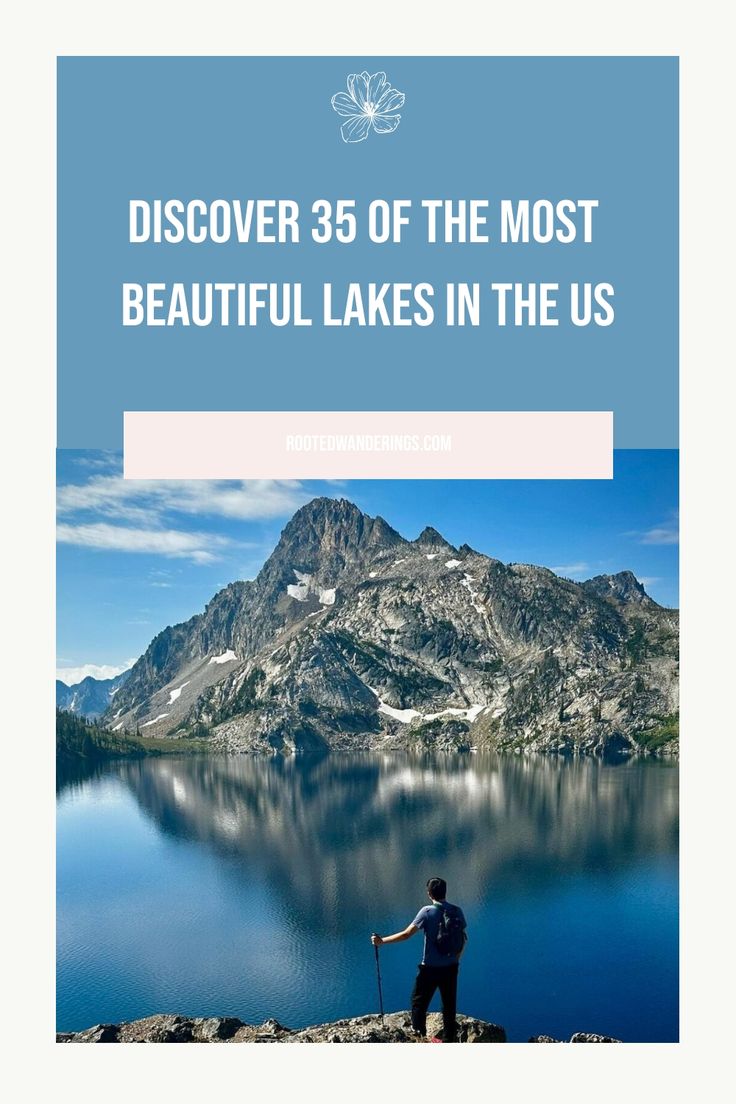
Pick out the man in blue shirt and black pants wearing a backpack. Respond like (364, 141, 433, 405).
(371, 878, 468, 1042)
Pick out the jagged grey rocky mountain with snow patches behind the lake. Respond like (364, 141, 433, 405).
(104, 498, 679, 752)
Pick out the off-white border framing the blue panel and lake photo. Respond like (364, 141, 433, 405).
(0, 0, 734, 1104)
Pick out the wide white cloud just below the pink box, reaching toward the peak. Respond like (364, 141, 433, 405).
(56, 475, 310, 524)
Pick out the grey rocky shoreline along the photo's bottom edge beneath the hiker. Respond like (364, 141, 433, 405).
(56, 1012, 620, 1043)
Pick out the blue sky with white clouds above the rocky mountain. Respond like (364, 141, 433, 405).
(57, 449, 678, 681)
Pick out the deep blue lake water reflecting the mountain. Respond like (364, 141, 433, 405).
(57, 754, 678, 1041)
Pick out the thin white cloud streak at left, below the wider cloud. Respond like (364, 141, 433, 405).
(56, 521, 233, 564)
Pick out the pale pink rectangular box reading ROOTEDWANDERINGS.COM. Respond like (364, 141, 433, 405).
(124, 411, 614, 479)
